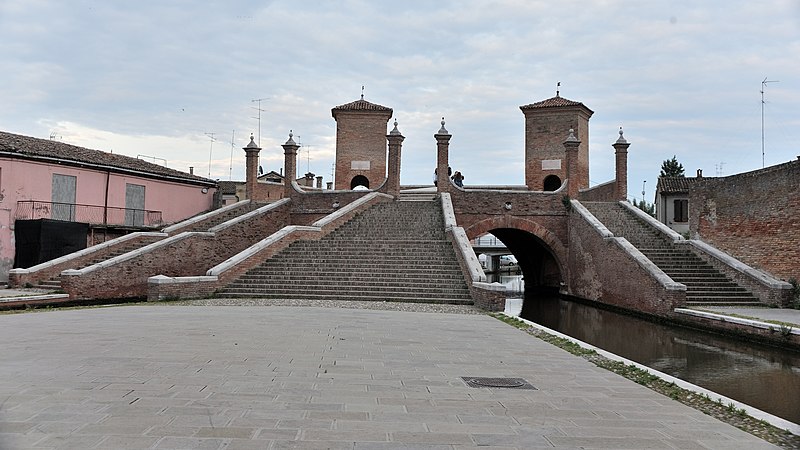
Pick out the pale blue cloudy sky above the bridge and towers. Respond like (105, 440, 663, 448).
(0, 0, 800, 201)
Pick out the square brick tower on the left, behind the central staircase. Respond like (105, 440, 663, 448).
(331, 94, 393, 189)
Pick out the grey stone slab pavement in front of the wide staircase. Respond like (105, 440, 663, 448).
(0, 305, 775, 450)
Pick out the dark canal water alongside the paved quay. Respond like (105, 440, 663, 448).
(520, 295, 800, 424)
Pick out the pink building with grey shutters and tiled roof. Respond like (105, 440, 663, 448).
(0, 132, 217, 282)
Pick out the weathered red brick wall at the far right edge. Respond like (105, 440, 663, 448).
(689, 159, 800, 280)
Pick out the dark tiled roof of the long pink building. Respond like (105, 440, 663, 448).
(0, 131, 215, 184)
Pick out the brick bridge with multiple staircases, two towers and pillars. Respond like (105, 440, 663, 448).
(10, 95, 791, 316)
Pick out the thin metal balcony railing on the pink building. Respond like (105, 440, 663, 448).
(15, 200, 162, 228)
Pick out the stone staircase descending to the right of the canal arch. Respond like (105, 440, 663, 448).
(581, 202, 763, 306)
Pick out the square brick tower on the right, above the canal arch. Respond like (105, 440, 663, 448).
(519, 92, 594, 192)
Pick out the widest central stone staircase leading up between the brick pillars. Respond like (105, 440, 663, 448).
(219, 195, 473, 304)
